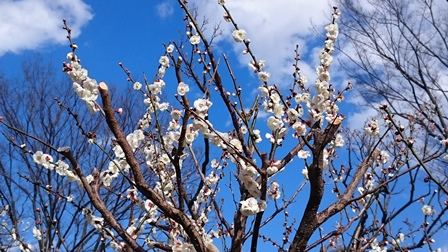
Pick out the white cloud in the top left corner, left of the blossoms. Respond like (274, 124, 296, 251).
(0, 0, 93, 57)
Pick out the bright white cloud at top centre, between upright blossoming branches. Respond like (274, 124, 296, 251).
(194, 0, 333, 86)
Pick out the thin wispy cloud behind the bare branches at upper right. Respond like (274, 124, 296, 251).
(338, 0, 448, 130)
